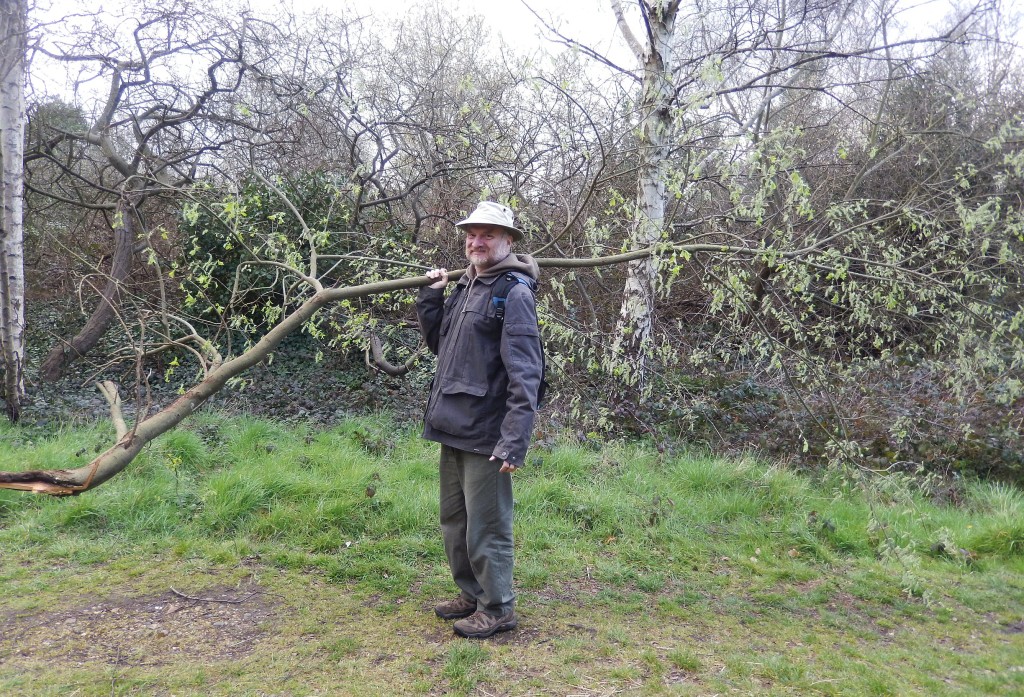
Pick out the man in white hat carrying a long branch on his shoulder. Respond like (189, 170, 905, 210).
(416, 201, 544, 639)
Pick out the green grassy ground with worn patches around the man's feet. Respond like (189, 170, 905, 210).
(0, 413, 1024, 695)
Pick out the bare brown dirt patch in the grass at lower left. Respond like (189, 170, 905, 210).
(0, 583, 275, 665)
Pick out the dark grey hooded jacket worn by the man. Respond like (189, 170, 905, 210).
(416, 254, 544, 466)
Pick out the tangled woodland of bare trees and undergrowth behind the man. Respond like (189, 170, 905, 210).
(4, 0, 1024, 489)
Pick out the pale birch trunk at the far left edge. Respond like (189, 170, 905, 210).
(0, 0, 29, 423)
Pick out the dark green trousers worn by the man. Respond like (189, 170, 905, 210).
(440, 445, 515, 615)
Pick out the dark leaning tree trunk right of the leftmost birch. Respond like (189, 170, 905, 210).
(39, 194, 137, 382)
